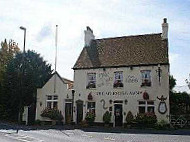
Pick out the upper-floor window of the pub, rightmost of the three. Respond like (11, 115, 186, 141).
(141, 70, 151, 86)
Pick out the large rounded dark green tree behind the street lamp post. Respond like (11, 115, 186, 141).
(2, 50, 52, 120)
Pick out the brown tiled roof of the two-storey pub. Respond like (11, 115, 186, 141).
(73, 33, 169, 69)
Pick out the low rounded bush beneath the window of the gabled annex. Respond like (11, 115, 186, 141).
(41, 108, 63, 121)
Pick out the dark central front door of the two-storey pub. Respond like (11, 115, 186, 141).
(114, 104, 123, 127)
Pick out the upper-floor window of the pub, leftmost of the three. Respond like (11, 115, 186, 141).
(86, 73, 96, 89)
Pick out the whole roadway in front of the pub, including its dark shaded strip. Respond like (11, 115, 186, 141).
(0, 123, 190, 142)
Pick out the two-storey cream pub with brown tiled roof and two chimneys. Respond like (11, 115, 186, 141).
(73, 18, 169, 127)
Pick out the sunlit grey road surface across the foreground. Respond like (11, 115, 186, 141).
(0, 122, 190, 142)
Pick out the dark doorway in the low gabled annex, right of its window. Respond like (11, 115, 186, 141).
(65, 103, 72, 124)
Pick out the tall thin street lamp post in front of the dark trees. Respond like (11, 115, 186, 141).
(17, 26, 26, 133)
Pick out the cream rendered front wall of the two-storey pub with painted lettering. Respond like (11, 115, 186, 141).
(73, 65, 170, 122)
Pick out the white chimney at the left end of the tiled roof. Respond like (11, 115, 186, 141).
(84, 26, 95, 46)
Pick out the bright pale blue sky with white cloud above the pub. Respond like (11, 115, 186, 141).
(0, 0, 190, 92)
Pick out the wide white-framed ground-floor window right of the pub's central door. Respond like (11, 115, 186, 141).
(139, 101, 154, 113)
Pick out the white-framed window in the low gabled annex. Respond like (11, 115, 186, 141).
(46, 95, 58, 109)
